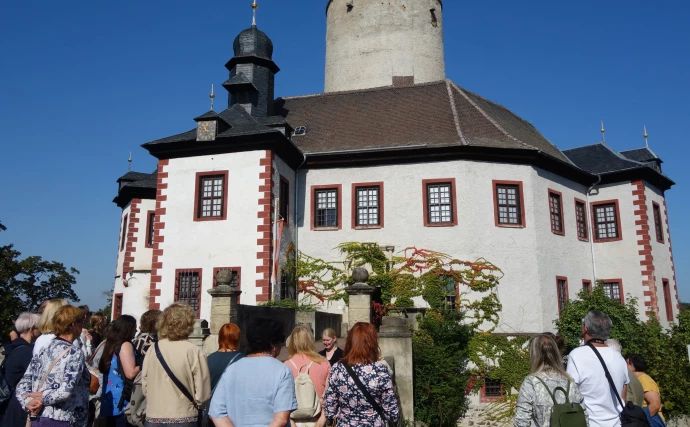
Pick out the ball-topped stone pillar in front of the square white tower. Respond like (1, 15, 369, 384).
(204, 270, 242, 354)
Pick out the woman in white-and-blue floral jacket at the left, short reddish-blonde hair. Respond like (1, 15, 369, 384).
(16, 305, 91, 427)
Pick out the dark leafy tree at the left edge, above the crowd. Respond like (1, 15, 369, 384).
(0, 245, 79, 337)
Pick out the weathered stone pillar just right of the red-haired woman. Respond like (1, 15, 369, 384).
(379, 316, 414, 421)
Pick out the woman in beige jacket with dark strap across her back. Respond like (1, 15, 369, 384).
(141, 303, 211, 427)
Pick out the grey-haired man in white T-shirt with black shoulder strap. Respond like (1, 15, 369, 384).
(567, 310, 630, 427)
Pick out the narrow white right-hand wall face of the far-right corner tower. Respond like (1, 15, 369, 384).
(644, 182, 678, 326)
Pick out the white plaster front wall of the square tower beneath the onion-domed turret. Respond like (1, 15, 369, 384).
(158, 150, 265, 319)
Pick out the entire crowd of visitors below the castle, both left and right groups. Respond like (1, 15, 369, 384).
(0, 299, 665, 427)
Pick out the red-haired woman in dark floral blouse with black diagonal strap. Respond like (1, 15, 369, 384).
(317, 322, 400, 427)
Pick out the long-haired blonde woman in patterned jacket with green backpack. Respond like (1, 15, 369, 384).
(513, 334, 584, 427)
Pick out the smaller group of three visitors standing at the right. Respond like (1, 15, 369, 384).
(513, 310, 665, 427)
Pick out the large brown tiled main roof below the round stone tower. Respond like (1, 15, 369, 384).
(276, 80, 570, 163)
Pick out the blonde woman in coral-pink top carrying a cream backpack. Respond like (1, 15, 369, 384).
(285, 326, 331, 427)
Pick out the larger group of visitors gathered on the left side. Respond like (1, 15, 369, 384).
(0, 299, 400, 427)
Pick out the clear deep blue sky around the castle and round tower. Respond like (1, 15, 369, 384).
(0, 0, 690, 308)
